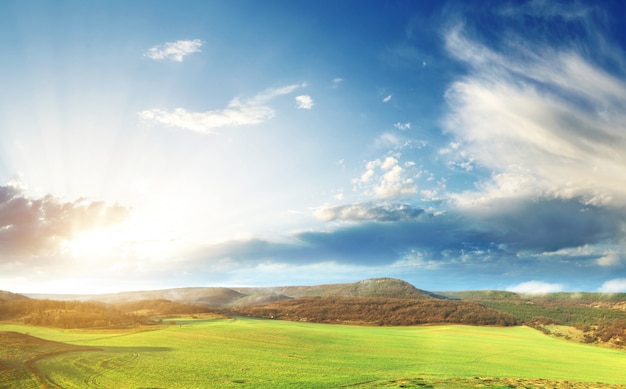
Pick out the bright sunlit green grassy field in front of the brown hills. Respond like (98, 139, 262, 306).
(0, 318, 626, 388)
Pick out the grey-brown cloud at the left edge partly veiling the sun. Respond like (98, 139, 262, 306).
(0, 185, 130, 256)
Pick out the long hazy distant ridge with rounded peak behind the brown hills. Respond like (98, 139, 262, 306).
(28, 278, 445, 307)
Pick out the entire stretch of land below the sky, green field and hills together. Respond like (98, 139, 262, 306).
(0, 278, 626, 389)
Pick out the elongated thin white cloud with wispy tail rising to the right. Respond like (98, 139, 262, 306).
(139, 84, 305, 134)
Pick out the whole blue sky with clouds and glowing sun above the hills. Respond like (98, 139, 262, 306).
(0, 0, 626, 293)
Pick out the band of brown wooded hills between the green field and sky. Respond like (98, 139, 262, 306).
(0, 278, 626, 347)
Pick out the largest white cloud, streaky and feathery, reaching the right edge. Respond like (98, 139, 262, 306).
(445, 26, 626, 205)
